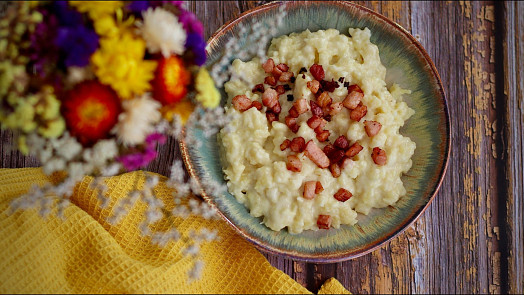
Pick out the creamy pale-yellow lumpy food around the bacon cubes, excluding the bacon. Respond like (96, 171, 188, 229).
(219, 28, 416, 233)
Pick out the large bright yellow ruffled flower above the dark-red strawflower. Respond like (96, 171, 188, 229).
(91, 34, 157, 99)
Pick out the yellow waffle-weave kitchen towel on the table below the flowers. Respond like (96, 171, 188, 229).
(0, 168, 347, 294)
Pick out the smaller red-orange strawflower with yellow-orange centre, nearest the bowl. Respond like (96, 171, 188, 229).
(153, 56, 191, 105)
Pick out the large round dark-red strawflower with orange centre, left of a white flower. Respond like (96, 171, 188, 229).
(62, 81, 121, 144)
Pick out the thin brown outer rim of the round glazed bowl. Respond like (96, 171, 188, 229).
(179, 1, 451, 263)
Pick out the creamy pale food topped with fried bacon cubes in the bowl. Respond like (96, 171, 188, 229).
(219, 28, 416, 233)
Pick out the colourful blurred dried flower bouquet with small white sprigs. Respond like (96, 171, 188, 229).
(0, 1, 230, 278)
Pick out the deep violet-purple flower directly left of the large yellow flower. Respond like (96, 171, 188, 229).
(55, 25, 98, 67)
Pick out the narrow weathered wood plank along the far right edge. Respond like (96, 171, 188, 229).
(500, 1, 524, 294)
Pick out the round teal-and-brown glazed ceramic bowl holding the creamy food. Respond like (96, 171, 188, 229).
(181, 1, 450, 263)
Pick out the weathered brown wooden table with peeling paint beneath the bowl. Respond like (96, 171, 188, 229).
(0, 1, 524, 293)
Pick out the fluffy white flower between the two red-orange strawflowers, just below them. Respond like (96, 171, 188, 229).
(113, 93, 162, 145)
